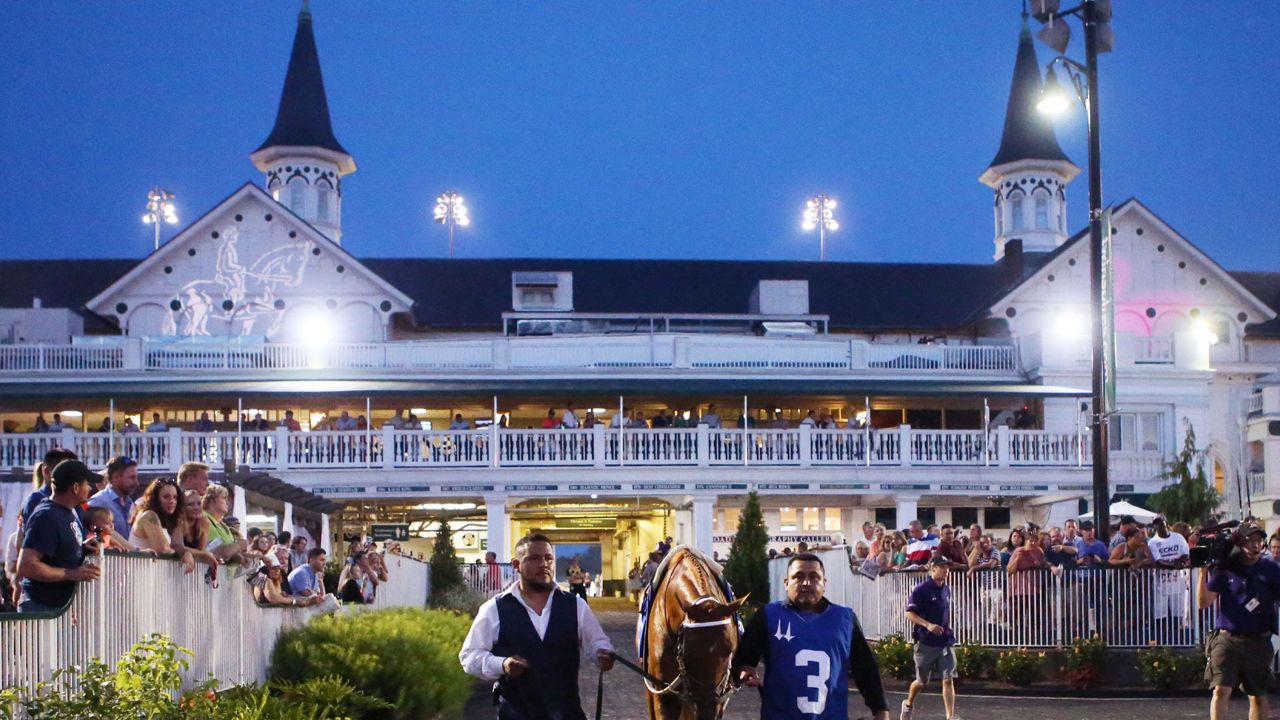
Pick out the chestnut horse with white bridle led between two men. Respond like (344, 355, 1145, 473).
(641, 546, 746, 720)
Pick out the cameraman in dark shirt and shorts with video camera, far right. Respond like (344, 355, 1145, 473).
(1196, 523, 1280, 720)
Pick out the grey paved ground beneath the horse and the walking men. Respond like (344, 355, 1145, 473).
(463, 612, 1254, 720)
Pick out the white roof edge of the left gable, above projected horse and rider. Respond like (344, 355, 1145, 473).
(83, 182, 413, 313)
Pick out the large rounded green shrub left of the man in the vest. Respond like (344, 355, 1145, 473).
(270, 609, 472, 720)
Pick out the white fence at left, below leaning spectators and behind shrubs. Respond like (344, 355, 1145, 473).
(0, 553, 428, 687)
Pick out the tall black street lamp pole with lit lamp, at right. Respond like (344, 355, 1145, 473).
(1032, 0, 1115, 542)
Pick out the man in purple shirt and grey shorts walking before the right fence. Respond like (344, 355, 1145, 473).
(900, 557, 957, 720)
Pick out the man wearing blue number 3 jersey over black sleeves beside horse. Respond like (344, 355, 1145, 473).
(733, 553, 888, 720)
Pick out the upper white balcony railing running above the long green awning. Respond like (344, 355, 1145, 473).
(0, 334, 1020, 374)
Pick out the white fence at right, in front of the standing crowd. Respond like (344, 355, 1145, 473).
(769, 547, 1244, 648)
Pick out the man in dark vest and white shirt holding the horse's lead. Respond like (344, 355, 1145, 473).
(458, 534, 613, 720)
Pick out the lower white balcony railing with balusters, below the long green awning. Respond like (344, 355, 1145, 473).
(0, 425, 1089, 471)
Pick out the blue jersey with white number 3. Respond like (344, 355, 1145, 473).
(760, 602, 854, 720)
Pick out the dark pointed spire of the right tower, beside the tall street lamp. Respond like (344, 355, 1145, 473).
(989, 16, 1071, 168)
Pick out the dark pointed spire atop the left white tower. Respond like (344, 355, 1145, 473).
(259, 6, 349, 155)
